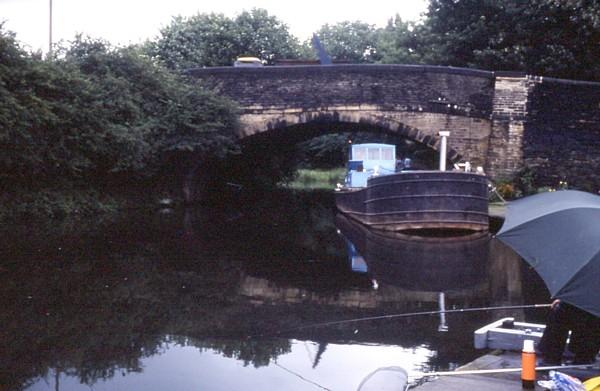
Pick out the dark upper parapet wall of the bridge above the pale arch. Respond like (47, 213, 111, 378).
(189, 65, 493, 118)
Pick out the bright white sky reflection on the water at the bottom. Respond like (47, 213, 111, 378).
(28, 340, 428, 391)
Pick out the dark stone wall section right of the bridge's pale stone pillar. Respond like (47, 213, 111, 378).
(523, 78, 600, 192)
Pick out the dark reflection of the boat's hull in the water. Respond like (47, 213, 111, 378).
(336, 214, 490, 293)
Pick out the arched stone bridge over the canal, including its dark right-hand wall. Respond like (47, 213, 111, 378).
(189, 65, 600, 192)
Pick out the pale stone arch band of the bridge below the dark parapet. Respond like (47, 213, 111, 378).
(240, 106, 491, 166)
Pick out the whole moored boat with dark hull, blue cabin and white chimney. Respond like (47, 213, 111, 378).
(335, 132, 489, 232)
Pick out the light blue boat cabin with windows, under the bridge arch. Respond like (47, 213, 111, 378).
(346, 144, 396, 187)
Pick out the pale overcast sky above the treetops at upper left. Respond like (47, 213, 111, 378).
(0, 0, 428, 52)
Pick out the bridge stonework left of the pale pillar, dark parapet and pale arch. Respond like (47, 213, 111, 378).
(190, 65, 494, 166)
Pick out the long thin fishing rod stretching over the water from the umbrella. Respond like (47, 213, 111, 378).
(248, 304, 551, 338)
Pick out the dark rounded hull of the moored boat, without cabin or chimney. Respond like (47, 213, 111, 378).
(335, 171, 489, 231)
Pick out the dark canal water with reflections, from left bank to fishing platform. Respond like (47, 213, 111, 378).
(0, 191, 548, 391)
